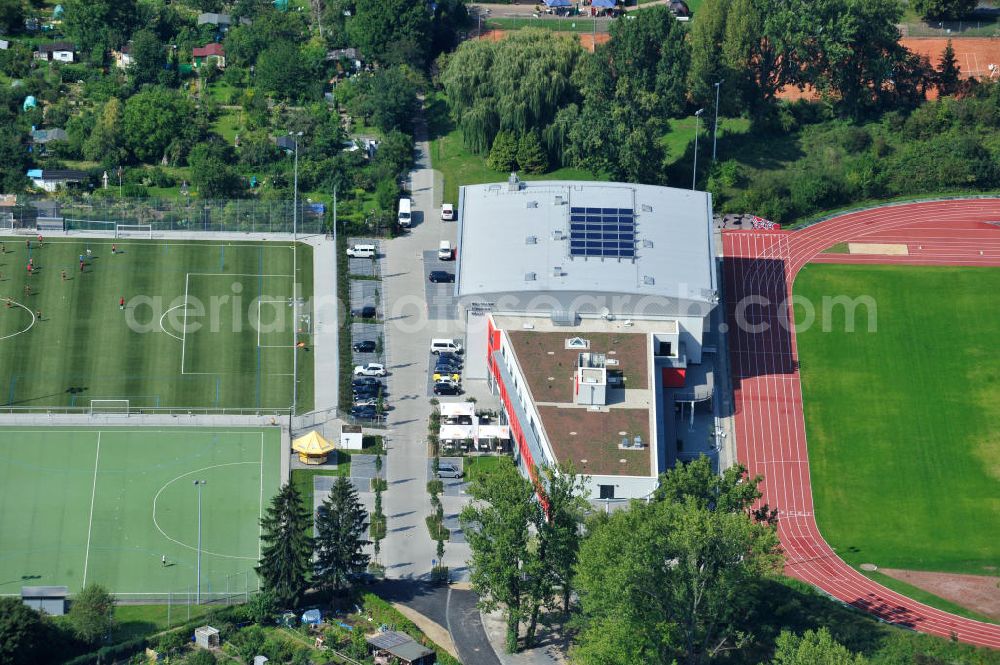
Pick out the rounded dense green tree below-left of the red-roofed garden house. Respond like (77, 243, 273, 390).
(122, 86, 194, 162)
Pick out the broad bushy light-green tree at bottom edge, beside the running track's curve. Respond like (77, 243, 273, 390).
(574, 462, 781, 665)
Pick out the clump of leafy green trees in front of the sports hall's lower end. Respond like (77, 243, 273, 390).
(460, 458, 781, 665)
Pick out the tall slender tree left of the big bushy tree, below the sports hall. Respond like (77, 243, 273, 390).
(459, 457, 540, 652)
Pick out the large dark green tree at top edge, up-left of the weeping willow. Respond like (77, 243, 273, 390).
(347, 0, 431, 68)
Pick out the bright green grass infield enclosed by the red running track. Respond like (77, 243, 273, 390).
(795, 264, 1000, 575)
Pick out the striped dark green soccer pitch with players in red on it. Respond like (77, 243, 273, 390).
(0, 237, 313, 411)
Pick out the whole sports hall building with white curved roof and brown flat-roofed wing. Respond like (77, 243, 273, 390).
(455, 174, 718, 499)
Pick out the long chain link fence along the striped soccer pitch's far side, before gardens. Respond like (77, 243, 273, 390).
(3, 197, 328, 234)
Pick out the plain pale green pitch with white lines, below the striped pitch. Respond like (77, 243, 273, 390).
(0, 427, 281, 600)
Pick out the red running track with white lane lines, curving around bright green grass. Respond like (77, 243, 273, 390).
(722, 199, 1000, 648)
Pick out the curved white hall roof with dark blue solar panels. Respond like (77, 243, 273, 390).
(456, 175, 717, 303)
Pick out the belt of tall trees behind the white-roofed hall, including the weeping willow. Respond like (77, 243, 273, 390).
(438, 0, 968, 183)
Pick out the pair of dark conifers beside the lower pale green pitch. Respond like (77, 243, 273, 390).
(257, 476, 371, 607)
